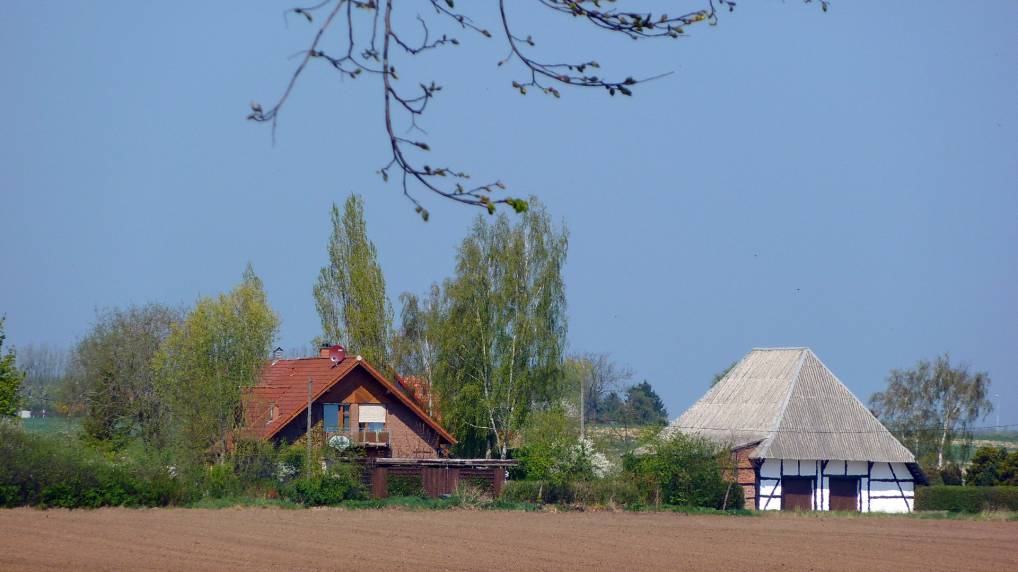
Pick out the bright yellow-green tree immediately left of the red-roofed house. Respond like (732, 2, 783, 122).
(155, 265, 279, 462)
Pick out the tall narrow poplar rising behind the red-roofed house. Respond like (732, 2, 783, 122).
(315, 194, 392, 367)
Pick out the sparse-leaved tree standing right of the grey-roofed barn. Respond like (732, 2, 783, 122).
(869, 354, 994, 469)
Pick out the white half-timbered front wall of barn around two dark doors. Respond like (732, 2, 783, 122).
(756, 459, 915, 512)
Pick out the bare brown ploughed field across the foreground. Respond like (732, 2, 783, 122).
(0, 509, 1018, 572)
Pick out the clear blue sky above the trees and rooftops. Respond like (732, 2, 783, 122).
(0, 0, 1018, 423)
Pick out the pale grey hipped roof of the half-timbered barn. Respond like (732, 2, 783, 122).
(667, 348, 915, 463)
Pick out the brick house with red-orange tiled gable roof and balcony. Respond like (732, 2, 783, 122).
(246, 346, 456, 459)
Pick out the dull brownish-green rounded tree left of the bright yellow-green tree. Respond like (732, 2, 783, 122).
(72, 303, 182, 446)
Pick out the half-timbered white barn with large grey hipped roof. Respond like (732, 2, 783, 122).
(666, 348, 925, 512)
